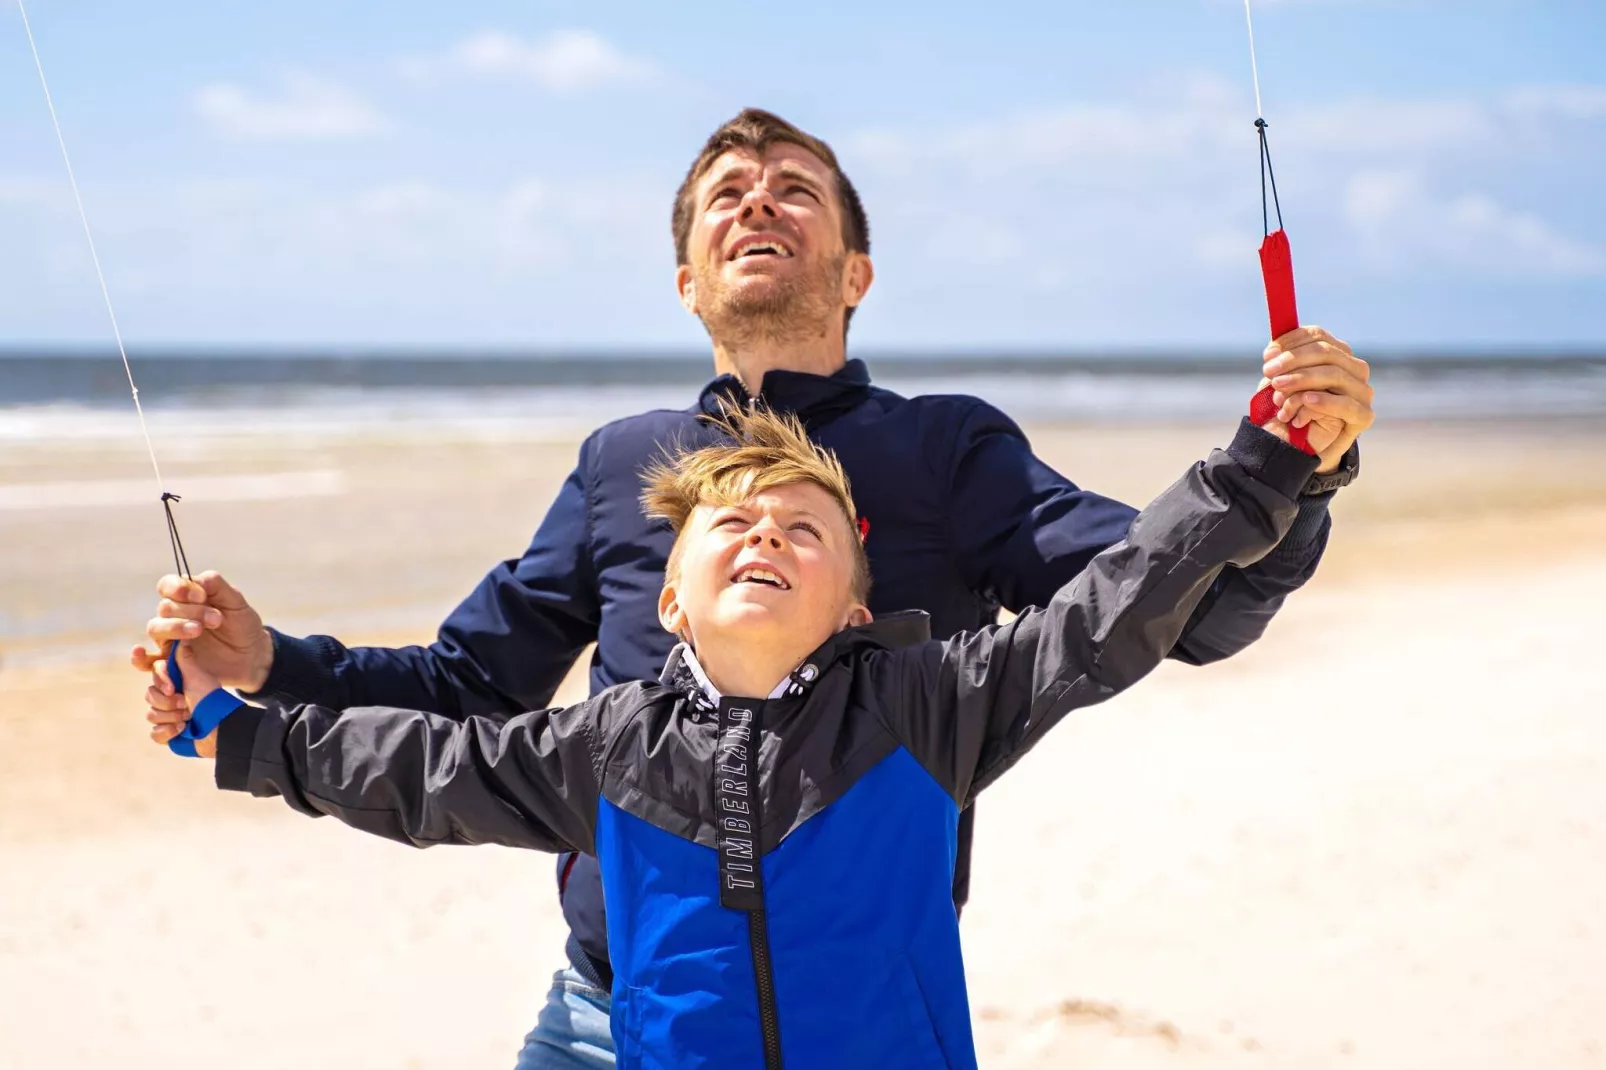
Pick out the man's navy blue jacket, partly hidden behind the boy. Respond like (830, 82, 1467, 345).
(251, 360, 1330, 986)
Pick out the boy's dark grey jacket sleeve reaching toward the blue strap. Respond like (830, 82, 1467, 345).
(215, 692, 613, 852)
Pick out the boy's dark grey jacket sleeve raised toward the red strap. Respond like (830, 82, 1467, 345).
(869, 424, 1317, 805)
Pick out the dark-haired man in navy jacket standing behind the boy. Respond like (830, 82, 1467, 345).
(133, 109, 1372, 1070)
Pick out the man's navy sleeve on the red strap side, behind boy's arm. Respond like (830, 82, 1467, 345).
(949, 402, 1331, 665)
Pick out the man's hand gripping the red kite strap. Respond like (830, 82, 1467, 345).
(1257, 326, 1375, 472)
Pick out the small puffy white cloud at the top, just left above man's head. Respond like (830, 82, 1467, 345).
(402, 29, 655, 93)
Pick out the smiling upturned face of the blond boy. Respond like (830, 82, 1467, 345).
(658, 484, 870, 659)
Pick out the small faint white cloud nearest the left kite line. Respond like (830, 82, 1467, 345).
(194, 74, 390, 141)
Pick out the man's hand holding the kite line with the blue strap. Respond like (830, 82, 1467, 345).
(128, 572, 273, 687)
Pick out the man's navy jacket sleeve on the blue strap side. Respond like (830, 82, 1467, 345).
(246, 440, 601, 720)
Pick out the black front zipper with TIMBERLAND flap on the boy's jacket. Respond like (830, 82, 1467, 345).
(713, 699, 782, 1070)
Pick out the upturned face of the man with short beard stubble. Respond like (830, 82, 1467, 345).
(676, 143, 870, 339)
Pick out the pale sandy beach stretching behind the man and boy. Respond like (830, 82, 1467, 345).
(0, 414, 1606, 1070)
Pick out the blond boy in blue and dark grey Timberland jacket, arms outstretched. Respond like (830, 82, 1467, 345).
(169, 401, 1317, 1068)
